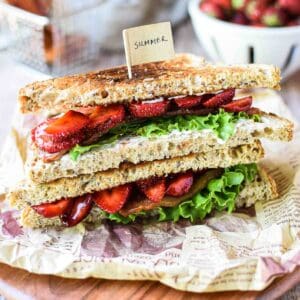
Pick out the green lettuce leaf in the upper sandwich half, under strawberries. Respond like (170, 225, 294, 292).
(69, 109, 260, 161)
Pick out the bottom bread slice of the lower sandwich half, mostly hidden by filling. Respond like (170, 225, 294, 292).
(21, 167, 278, 228)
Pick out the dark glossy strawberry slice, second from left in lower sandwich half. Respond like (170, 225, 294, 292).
(60, 194, 93, 227)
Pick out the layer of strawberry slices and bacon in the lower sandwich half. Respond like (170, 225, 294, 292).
(32, 169, 231, 227)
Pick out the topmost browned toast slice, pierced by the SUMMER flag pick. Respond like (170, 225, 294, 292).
(19, 54, 280, 113)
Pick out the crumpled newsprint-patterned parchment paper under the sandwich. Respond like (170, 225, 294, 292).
(0, 92, 300, 292)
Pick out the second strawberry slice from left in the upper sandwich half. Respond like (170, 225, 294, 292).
(82, 104, 125, 133)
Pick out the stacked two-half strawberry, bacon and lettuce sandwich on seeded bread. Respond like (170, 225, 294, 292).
(9, 54, 293, 228)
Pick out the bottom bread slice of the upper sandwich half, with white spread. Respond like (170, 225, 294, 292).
(26, 113, 293, 183)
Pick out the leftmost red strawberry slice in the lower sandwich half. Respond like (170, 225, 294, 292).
(31, 198, 72, 218)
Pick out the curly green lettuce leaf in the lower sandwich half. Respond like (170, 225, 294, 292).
(107, 164, 258, 224)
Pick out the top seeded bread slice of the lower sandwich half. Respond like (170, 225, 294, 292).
(9, 140, 264, 208)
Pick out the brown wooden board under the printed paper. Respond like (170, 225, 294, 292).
(0, 264, 300, 300)
